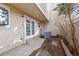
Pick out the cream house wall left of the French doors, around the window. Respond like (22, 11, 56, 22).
(0, 4, 42, 53)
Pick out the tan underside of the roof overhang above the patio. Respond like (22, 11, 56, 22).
(5, 3, 48, 22)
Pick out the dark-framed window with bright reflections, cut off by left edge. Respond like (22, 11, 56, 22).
(0, 7, 9, 25)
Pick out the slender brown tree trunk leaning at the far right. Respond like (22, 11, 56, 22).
(68, 12, 79, 55)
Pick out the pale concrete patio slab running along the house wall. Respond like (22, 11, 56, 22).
(0, 38, 45, 56)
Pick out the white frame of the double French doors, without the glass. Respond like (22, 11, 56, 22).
(24, 16, 39, 40)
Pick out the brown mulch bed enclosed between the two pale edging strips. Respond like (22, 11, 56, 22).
(44, 38, 66, 56)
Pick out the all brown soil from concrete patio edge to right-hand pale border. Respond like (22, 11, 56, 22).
(30, 37, 66, 56)
